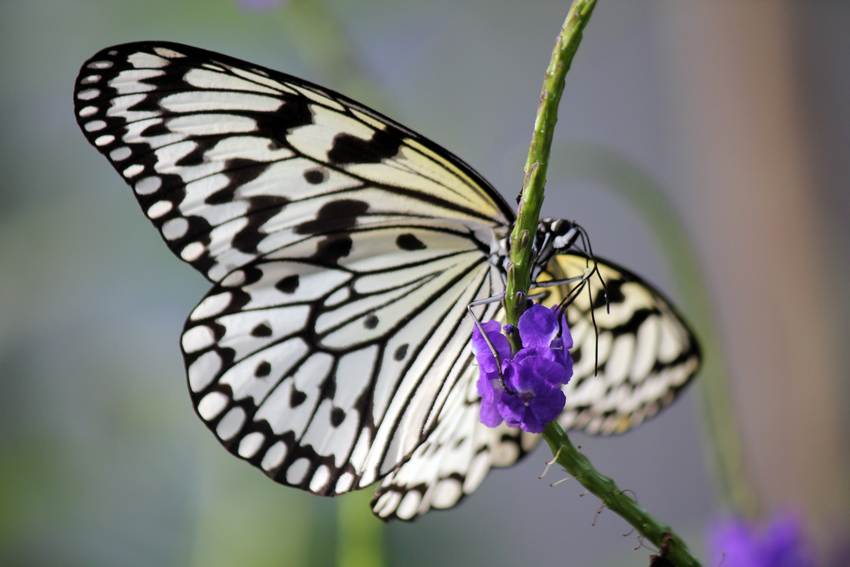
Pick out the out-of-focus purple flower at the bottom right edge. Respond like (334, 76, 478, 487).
(707, 513, 817, 567)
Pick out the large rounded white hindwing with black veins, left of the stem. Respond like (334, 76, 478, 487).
(183, 228, 501, 494)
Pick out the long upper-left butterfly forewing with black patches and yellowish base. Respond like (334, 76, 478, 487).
(75, 43, 511, 282)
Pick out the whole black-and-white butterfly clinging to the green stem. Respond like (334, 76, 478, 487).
(74, 42, 701, 520)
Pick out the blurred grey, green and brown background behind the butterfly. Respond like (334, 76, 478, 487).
(0, 0, 850, 567)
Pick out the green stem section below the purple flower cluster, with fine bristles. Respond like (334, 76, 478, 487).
(543, 422, 699, 567)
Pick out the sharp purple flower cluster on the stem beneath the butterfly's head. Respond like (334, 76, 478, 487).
(472, 304, 573, 433)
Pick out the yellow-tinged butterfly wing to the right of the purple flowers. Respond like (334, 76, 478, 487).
(547, 254, 701, 435)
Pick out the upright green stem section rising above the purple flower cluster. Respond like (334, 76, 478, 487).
(505, 0, 596, 338)
